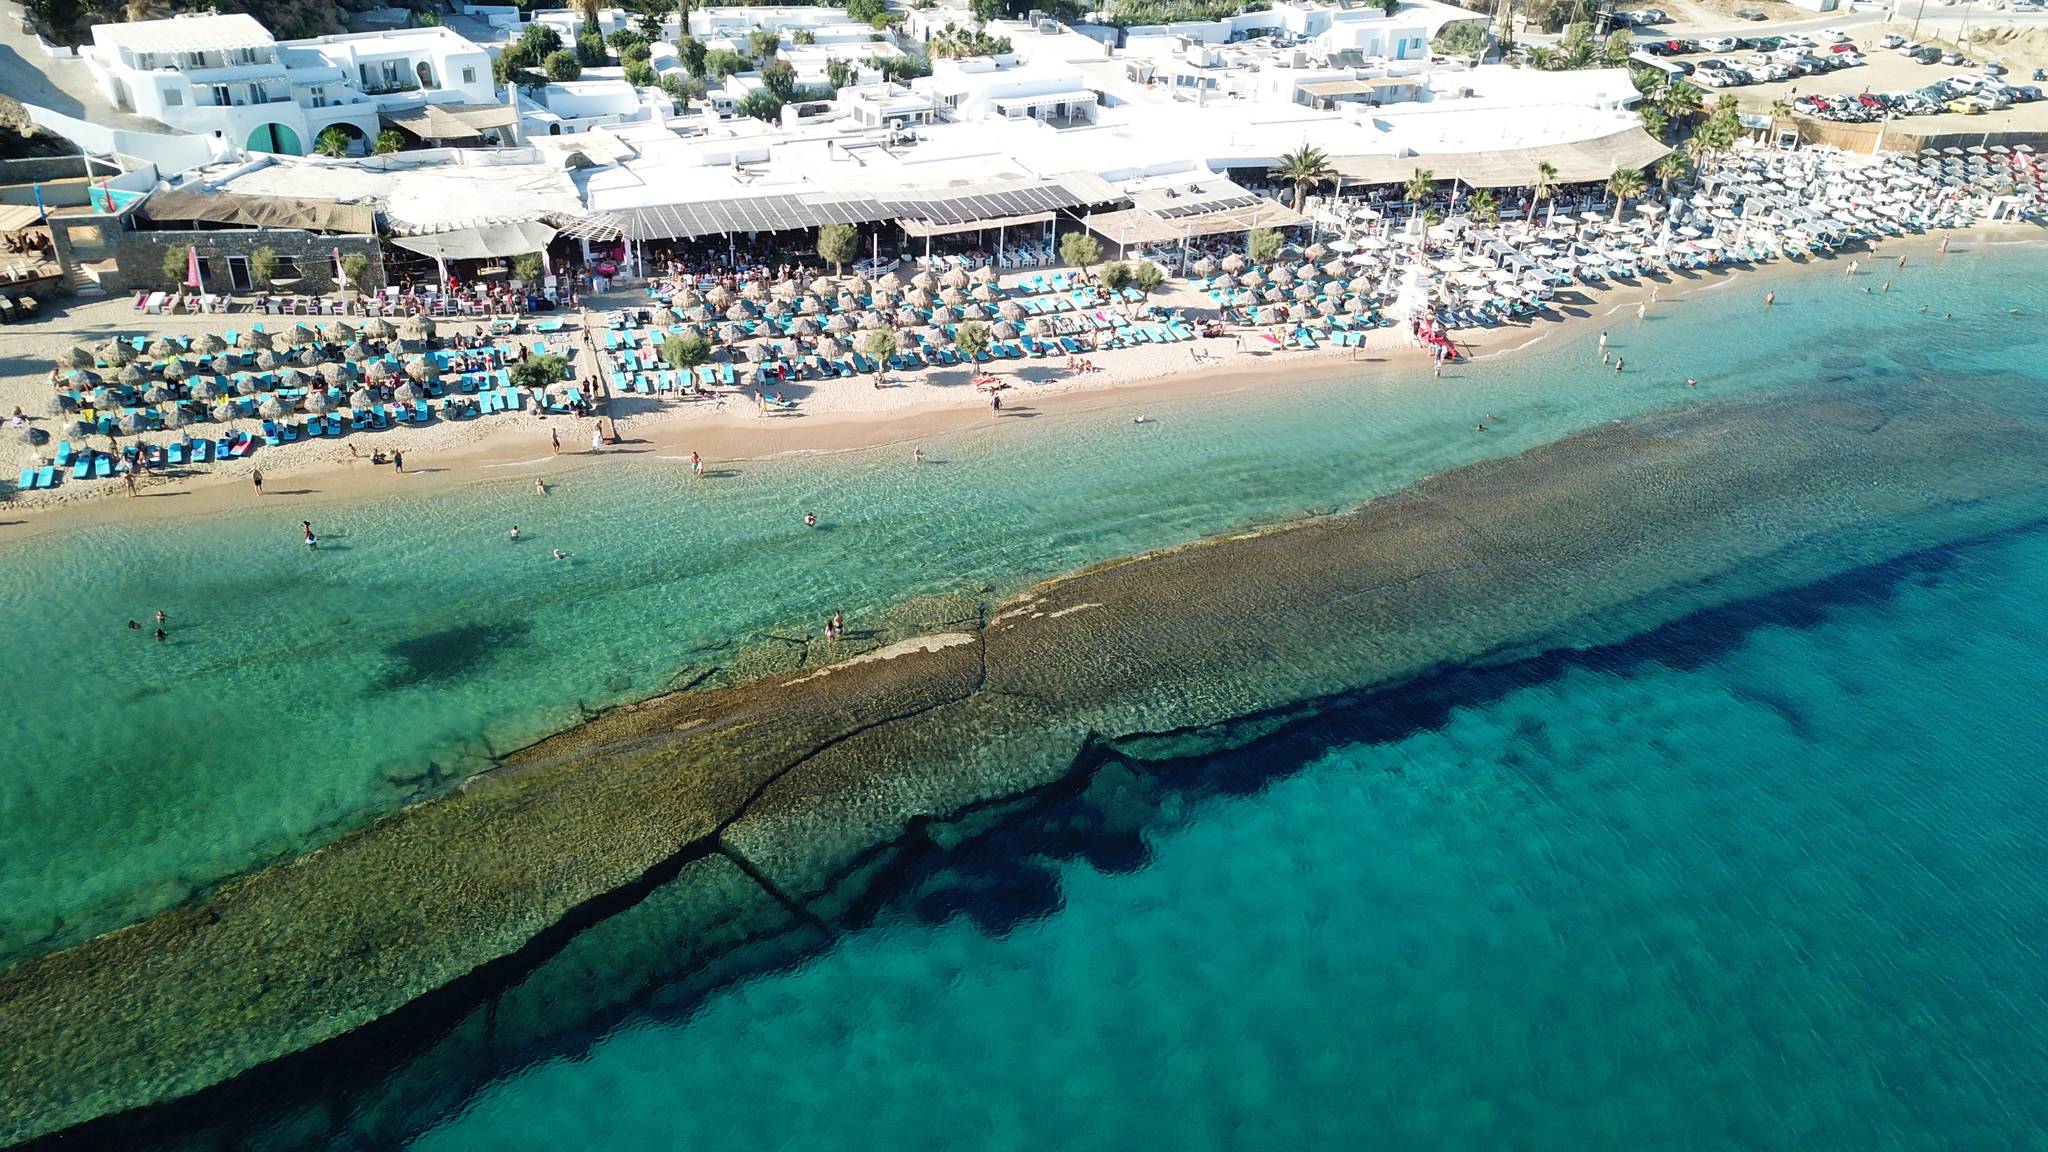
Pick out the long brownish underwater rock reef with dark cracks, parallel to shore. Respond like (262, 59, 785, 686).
(0, 385, 2048, 1144)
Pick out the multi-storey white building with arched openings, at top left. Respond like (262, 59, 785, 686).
(80, 12, 498, 156)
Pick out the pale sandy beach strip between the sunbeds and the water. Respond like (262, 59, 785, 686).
(0, 225, 2040, 537)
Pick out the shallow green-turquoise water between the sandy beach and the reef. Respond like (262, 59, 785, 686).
(0, 250, 2048, 963)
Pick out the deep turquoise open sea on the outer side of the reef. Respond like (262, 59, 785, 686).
(407, 518, 2048, 1152)
